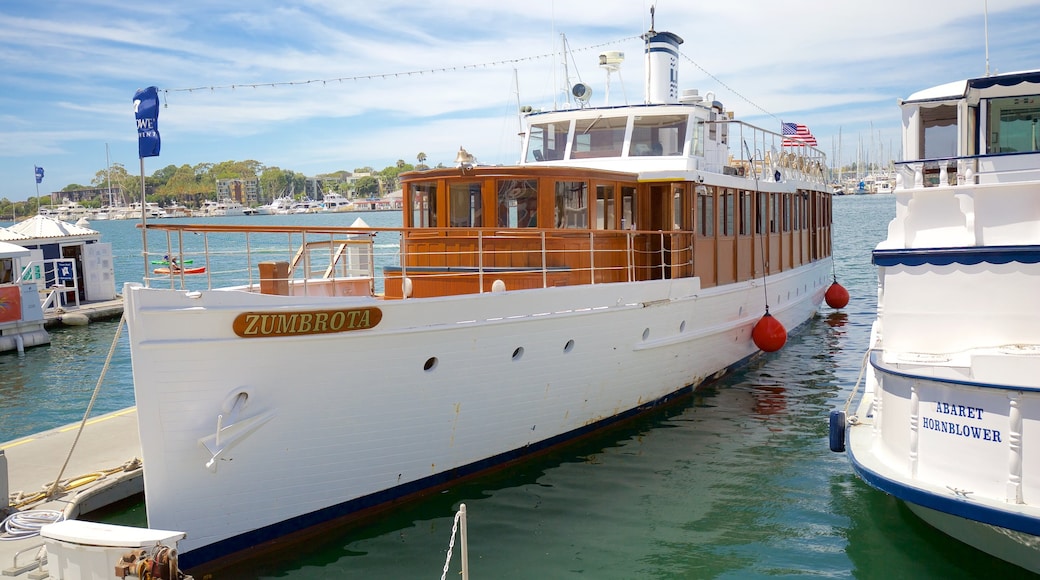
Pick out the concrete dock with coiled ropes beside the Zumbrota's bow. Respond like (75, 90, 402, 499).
(0, 407, 144, 578)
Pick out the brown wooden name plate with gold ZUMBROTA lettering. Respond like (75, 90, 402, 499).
(232, 308, 383, 338)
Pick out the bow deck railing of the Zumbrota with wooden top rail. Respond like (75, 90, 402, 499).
(144, 222, 715, 296)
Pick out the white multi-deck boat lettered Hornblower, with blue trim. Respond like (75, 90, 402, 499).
(830, 70, 1040, 573)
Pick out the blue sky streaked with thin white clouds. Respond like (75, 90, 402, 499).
(0, 0, 1040, 201)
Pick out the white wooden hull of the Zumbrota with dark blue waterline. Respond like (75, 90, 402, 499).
(125, 260, 831, 566)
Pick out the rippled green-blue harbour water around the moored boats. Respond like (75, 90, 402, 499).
(0, 195, 1025, 580)
